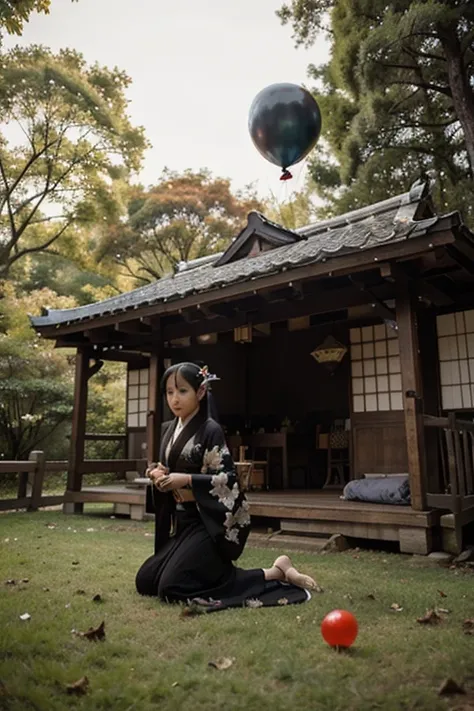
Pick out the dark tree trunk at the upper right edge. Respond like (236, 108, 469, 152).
(438, 24, 474, 177)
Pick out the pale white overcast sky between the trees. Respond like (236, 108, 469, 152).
(4, 0, 328, 199)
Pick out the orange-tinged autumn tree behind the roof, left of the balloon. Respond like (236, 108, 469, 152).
(97, 170, 261, 283)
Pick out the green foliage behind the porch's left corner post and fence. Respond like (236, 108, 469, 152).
(0, 282, 125, 459)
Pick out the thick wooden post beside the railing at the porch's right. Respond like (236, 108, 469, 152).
(396, 275, 426, 511)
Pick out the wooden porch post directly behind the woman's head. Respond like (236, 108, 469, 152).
(146, 321, 163, 464)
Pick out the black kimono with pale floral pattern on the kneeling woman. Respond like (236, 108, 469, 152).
(136, 412, 310, 612)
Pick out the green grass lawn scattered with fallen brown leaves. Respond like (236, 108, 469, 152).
(0, 511, 474, 711)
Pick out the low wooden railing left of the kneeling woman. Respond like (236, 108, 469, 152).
(0, 451, 147, 511)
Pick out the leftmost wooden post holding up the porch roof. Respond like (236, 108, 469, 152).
(63, 348, 89, 513)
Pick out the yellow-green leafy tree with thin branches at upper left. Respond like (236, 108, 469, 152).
(0, 46, 146, 279)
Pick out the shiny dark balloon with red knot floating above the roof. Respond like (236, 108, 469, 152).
(249, 84, 321, 177)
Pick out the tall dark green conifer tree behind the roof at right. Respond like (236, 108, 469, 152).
(279, 0, 474, 219)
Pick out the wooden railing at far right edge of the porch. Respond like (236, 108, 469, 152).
(423, 413, 474, 513)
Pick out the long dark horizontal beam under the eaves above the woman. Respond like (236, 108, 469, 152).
(163, 285, 394, 341)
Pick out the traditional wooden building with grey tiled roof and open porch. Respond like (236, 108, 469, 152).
(32, 182, 474, 553)
